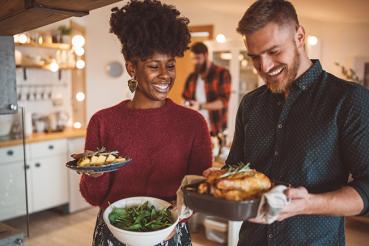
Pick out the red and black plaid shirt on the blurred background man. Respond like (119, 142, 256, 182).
(182, 63, 231, 134)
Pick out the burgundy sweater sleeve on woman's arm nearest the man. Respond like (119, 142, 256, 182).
(188, 117, 212, 175)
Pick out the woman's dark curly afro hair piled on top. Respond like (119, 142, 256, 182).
(110, 0, 191, 61)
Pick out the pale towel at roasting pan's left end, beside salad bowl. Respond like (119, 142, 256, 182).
(177, 175, 205, 221)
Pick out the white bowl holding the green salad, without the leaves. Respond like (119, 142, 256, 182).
(103, 196, 178, 246)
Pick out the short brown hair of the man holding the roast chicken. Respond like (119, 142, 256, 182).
(237, 0, 299, 35)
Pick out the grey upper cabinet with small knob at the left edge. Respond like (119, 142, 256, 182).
(0, 36, 18, 114)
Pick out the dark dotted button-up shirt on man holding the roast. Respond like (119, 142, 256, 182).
(227, 61, 369, 246)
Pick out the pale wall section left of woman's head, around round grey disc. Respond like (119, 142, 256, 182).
(84, 5, 130, 119)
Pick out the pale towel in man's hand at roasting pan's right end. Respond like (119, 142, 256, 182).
(256, 185, 290, 224)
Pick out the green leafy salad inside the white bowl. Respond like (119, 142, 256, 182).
(109, 201, 173, 232)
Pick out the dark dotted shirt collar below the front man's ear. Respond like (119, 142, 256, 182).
(293, 60, 323, 90)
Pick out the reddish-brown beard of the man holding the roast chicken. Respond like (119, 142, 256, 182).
(266, 47, 300, 93)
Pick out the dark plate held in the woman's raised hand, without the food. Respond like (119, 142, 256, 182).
(65, 158, 132, 173)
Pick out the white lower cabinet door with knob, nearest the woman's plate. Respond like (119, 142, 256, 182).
(31, 154, 68, 212)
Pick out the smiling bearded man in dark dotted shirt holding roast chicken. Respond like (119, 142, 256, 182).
(226, 0, 369, 246)
